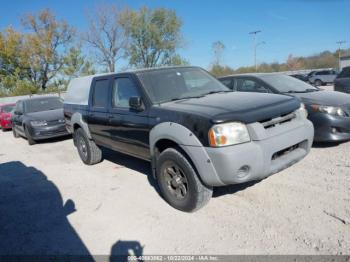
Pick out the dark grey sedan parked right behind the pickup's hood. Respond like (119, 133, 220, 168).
(220, 74, 350, 142)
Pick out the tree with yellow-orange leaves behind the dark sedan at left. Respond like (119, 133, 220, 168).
(22, 9, 74, 90)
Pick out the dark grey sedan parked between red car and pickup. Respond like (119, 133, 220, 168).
(12, 96, 69, 145)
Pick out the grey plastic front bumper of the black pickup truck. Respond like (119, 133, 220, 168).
(186, 112, 314, 186)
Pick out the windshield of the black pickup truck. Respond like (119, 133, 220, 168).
(137, 67, 231, 103)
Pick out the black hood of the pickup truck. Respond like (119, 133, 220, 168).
(161, 92, 300, 123)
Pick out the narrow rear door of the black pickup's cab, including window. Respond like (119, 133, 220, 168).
(87, 77, 110, 145)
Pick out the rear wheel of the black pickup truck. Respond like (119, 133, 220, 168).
(74, 128, 102, 165)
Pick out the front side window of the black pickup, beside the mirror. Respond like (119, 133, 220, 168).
(112, 77, 140, 108)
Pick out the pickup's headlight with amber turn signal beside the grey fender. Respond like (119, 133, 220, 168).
(208, 122, 250, 147)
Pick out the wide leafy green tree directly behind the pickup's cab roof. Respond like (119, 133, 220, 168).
(122, 7, 183, 67)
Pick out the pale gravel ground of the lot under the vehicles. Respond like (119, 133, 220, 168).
(0, 132, 350, 255)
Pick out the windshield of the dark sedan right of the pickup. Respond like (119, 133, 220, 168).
(260, 74, 319, 93)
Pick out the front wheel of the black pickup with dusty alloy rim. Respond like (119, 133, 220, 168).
(156, 148, 213, 212)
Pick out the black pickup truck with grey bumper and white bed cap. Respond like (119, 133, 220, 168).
(64, 67, 313, 212)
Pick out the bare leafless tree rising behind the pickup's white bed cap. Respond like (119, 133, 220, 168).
(83, 5, 127, 72)
